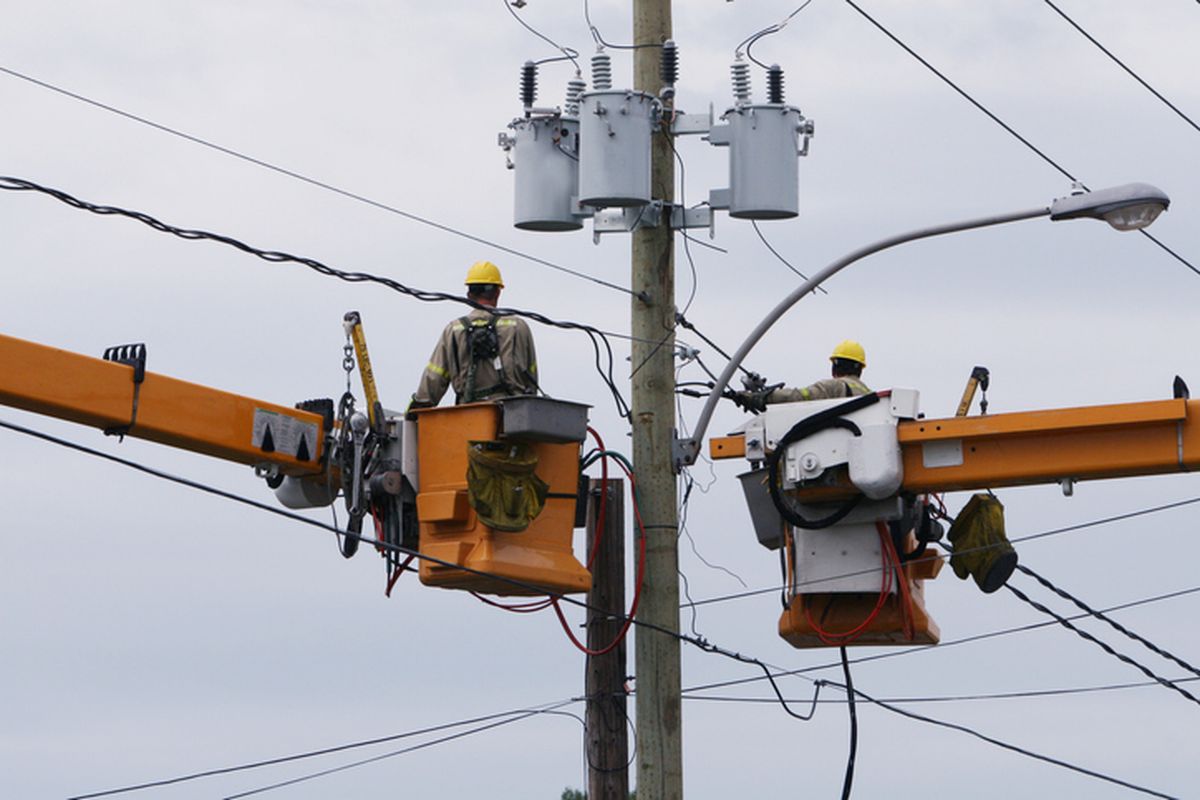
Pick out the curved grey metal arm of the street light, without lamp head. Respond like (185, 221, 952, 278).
(676, 207, 1050, 470)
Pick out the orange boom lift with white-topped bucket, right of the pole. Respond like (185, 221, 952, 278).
(709, 388, 1200, 646)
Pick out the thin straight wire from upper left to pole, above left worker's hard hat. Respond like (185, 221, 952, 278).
(0, 66, 636, 296)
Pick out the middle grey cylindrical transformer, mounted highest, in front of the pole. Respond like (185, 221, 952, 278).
(580, 90, 659, 207)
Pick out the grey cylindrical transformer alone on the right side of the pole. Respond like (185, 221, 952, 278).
(722, 104, 804, 219)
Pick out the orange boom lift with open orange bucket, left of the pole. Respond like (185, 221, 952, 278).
(0, 328, 592, 595)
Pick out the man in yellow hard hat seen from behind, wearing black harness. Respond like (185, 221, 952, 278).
(409, 261, 538, 409)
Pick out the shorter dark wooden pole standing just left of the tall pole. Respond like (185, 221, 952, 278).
(586, 480, 629, 800)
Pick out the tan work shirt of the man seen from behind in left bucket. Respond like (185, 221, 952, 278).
(413, 308, 538, 405)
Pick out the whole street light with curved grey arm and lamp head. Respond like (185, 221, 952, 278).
(672, 184, 1171, 471)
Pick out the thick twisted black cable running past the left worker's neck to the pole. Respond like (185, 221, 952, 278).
(0, 176, 629, 419)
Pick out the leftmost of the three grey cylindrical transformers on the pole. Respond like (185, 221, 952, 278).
(509, 116, 583, 230)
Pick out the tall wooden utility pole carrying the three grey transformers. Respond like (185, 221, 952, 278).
(630, 0, 683, 800)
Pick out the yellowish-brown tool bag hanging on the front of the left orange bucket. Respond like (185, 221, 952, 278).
(467, 441, 550, 531)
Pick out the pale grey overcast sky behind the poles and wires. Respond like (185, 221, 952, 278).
(0, 0, 1200, 799)
